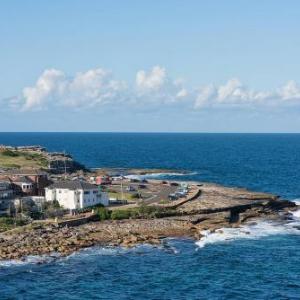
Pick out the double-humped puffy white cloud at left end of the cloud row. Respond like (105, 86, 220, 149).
(22, 69, 126, 110)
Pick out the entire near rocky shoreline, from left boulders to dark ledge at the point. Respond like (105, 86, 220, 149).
(0, 191, 297, 260)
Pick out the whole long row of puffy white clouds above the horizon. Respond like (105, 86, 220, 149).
(1, 66, 300, 112)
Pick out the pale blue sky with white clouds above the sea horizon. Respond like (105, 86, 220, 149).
(0, 0, 300, 132)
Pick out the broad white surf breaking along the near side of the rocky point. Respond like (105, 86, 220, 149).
(196, 204, 300, 248)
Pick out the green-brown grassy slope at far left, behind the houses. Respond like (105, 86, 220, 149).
(0, 151, 47, 168)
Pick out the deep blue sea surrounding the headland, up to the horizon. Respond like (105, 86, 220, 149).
(0, 133, 300, 299)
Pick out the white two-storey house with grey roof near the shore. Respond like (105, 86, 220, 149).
(45, 180, 109, 209)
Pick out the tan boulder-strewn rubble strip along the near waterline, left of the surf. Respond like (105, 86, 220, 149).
(0, 219, 189, 260)
